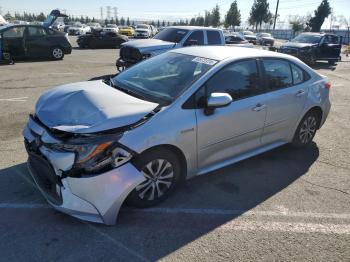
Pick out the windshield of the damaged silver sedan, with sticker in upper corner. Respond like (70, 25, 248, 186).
(112, 52, 217, 105)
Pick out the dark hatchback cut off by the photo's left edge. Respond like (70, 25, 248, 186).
(0, 25, 72, 60)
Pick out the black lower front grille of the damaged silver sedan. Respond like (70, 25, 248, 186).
(28, 150, 63, 205)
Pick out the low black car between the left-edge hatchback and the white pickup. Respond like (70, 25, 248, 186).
(77, 30, 129, 48)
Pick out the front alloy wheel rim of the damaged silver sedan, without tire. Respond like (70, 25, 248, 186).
(136, 159, 174, 201)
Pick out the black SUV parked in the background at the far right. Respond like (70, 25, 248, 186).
(279, 33, 342, 65)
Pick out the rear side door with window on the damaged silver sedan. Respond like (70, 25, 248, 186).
(261, 58, 309, 145)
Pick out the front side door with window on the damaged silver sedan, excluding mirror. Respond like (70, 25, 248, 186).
(196, 59, 266, 173)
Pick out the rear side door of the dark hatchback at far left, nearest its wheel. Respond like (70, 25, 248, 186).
(25, 26, 51, 57)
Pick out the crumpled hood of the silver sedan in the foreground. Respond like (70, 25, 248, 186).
(35, 80, 158, 134)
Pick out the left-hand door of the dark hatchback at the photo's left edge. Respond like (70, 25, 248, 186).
(2, 26, 25, 58)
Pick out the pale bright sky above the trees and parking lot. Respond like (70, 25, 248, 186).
(0, 0, 350, 24)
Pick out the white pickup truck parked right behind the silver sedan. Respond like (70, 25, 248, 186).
(116, 26, 225, 71)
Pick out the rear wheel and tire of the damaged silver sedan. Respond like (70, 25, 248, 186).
(292, 111, 320, 147)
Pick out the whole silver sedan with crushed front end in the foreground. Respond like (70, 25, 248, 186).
(23, 46, 330, 225)
